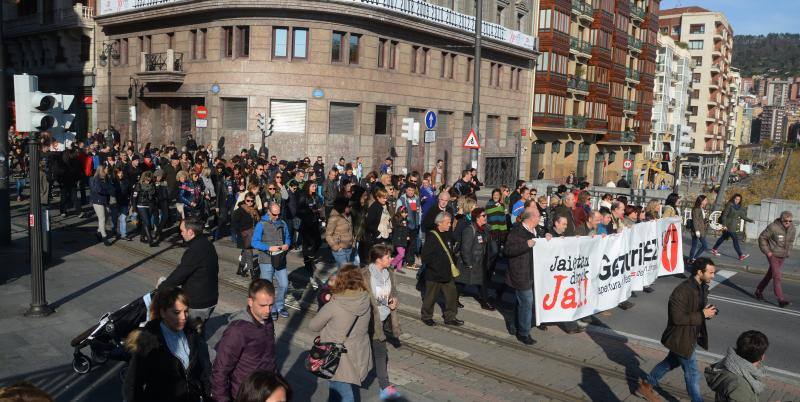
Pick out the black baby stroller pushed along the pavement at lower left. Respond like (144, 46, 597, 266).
(70, 293, 153, 374)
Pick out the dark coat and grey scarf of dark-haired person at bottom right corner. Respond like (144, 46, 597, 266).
(705, 348, 767, 402)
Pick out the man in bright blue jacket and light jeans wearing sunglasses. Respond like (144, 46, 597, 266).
(250, 202, 292, 321)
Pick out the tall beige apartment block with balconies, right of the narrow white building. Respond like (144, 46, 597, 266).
(659, 7, 734, 180)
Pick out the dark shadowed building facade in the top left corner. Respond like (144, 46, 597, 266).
(2, 0, 95, 135)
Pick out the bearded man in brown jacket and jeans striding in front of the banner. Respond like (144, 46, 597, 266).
(637, 258, 717, 402)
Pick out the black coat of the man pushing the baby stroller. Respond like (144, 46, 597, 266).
(158, 234, 219, 309)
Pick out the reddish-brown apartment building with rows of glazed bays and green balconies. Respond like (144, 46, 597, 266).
(529, 0, 659, 185)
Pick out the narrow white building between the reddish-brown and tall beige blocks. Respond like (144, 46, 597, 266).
(645, 35, 692, 185)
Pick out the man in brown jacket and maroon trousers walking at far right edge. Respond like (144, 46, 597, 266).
(755, 211, 796, 307)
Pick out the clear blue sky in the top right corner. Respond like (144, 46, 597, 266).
(660, 0, 800, 35)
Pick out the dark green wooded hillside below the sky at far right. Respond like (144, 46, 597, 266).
(731, 33, 800, 77)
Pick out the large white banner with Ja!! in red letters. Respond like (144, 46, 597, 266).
(533, 217, 684, 325)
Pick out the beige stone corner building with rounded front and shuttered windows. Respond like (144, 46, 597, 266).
(96, 0, 537, 184)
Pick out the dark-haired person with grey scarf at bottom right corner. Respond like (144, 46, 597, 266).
(705, 330, 769, 402)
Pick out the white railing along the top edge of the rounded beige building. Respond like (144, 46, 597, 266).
(99, 0, 539, 51)
